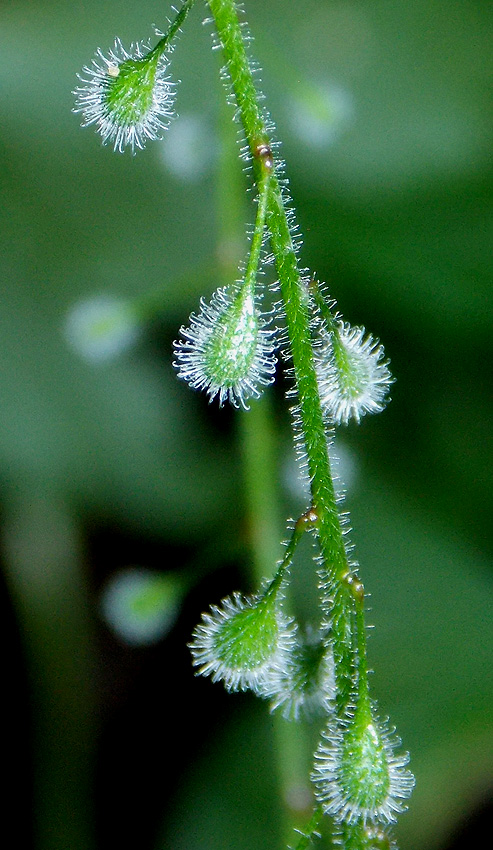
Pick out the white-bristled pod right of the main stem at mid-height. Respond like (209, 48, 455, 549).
(316, 322, 393, 425)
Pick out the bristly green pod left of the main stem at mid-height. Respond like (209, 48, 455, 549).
(174, 288, 276, 409)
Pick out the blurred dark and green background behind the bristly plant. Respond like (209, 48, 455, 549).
(0, 0, 493, 850)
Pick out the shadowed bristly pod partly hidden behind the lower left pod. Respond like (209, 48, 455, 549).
(271, 629, 335, 720)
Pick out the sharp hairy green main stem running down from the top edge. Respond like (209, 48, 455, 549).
(209, 0, 364, 715)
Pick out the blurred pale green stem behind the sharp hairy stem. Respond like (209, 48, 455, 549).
(217, 71, 310, 846)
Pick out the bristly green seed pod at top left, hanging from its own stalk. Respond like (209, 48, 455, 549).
(73, 39, 174, 153)
